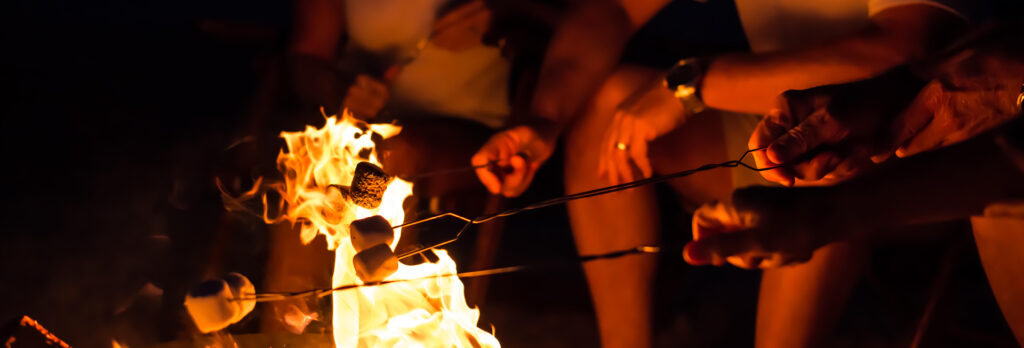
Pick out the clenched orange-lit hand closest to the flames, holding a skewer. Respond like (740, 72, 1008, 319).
(471, 126, 556, 197)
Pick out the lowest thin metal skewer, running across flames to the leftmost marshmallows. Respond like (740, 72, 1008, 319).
(232, 246, 662, 302)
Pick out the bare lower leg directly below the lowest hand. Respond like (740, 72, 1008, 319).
(756, 243, 867, 348)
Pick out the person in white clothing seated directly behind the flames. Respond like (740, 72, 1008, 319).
(263, 0, 510, 332)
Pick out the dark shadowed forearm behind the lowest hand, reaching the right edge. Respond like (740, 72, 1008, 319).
(823, 120, 1024, 230)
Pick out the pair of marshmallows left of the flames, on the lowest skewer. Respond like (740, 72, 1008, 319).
(185, 273, 256, 334)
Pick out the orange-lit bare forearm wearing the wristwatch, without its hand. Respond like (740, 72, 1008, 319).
(701, 5, 965, 114)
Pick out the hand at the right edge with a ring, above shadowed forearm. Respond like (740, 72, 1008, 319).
(873, 51, 1024, 161)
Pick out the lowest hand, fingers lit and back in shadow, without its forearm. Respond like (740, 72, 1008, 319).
(683, 186, 853, 268)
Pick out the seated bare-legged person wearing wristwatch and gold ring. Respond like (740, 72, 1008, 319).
(473, 0, 983, 347)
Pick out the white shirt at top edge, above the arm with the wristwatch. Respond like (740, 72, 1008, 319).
(735, 0, 966, 53)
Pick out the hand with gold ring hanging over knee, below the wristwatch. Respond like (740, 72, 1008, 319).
(597, 75, 684, 185)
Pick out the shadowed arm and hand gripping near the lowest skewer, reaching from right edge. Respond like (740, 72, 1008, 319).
(683, 118, 1024, 268)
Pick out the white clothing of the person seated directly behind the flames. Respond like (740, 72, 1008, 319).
(345, 0, 509, 128)
